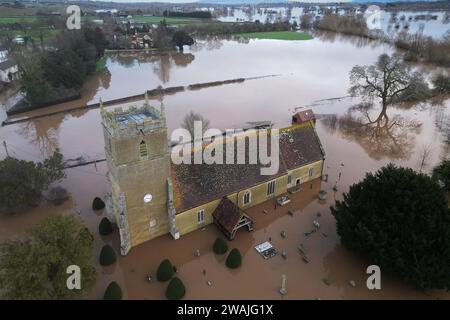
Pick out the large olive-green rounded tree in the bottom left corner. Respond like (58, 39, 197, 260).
(0, 213, 97, 301)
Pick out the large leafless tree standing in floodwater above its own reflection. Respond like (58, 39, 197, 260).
(349, 54, 428, 111)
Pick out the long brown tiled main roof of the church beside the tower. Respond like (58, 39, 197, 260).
(171, 125, 325, 213)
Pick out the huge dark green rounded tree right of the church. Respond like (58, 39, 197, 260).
(331, 165, 450, 289)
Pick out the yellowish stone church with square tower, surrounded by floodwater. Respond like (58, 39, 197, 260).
(100, 99, 325, 254)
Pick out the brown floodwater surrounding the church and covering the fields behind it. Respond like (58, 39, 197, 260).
(0, 31, 450, 299)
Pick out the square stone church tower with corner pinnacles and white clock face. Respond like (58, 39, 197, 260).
(100, 96, 179, 255)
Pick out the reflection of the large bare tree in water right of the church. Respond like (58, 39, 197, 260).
(321, 104, 422, 160)
